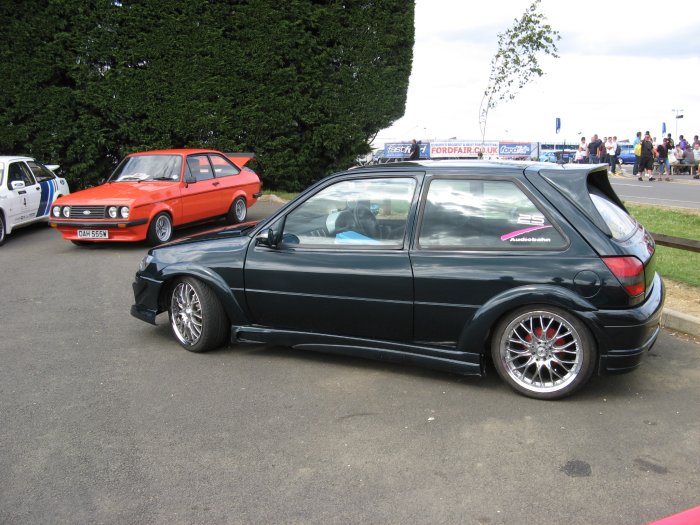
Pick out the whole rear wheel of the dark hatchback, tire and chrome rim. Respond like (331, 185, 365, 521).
(491, 305, 597, 399)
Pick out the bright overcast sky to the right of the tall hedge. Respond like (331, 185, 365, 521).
(375, 0, 700, 146)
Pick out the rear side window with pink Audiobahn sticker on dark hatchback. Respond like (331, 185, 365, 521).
(418, 179, 567, 250)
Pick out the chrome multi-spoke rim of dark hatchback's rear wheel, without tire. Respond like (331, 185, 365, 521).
(500, 310, 584, 393)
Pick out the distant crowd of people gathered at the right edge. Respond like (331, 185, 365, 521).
(574, 131, 700, 182)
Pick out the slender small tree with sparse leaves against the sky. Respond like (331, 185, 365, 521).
(479, 0, 561, 142)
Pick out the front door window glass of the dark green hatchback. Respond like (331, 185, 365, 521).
(282, 178, 416, 249)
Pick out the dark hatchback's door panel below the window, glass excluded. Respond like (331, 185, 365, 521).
(245, 246, 413, 341)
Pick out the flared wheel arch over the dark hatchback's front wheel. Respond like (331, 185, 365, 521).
(158, 263, 248, 325)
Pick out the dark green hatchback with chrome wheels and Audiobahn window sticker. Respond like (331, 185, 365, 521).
(131, 161, 664, 399)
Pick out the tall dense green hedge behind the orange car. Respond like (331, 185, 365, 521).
(0, 0, 414, 191)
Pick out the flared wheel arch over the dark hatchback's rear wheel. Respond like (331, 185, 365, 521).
(457, 285, 599, 355)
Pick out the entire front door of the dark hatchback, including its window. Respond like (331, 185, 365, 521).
(245, 176, 417, 341)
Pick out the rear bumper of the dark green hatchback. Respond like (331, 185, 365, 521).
(595, 274, 665, 375)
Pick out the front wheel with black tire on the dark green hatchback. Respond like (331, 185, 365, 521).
(168, 277, 231, 352)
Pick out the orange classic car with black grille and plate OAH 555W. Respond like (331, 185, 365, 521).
(49, 149, 261, 245)
